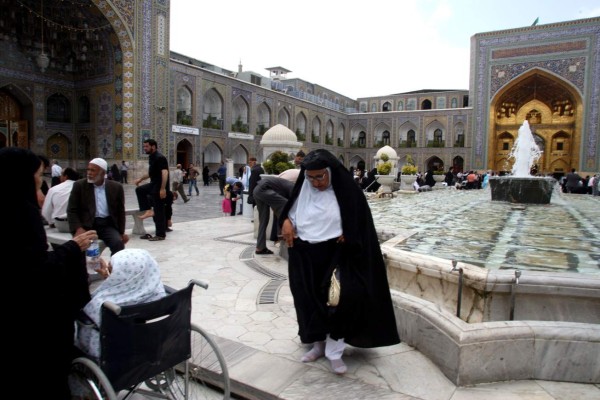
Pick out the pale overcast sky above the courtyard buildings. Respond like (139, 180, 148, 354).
(171, 0, 600, 99)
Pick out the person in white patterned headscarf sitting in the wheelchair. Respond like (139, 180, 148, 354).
(75, 249, 166, 359)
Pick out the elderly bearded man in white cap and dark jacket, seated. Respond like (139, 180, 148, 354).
(67, 158, 129, 255)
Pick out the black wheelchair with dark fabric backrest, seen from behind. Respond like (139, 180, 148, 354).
(69, 280, 230, 400)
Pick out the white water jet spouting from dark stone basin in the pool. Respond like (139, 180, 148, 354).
(490, 121, 556, 204)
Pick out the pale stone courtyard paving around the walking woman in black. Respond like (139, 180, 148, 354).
(115, 185, 600, 400)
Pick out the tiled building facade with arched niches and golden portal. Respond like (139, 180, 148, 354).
(0, 0, 600, 176)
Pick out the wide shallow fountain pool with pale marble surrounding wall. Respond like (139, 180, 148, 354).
(370, 174, 600, 386)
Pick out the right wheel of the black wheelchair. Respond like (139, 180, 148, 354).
(162, 324, 230, 400)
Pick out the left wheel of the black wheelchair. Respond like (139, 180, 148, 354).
(69, 357, 117, 400)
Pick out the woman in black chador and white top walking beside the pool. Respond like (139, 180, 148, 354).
(280, 149, 400, 374)
